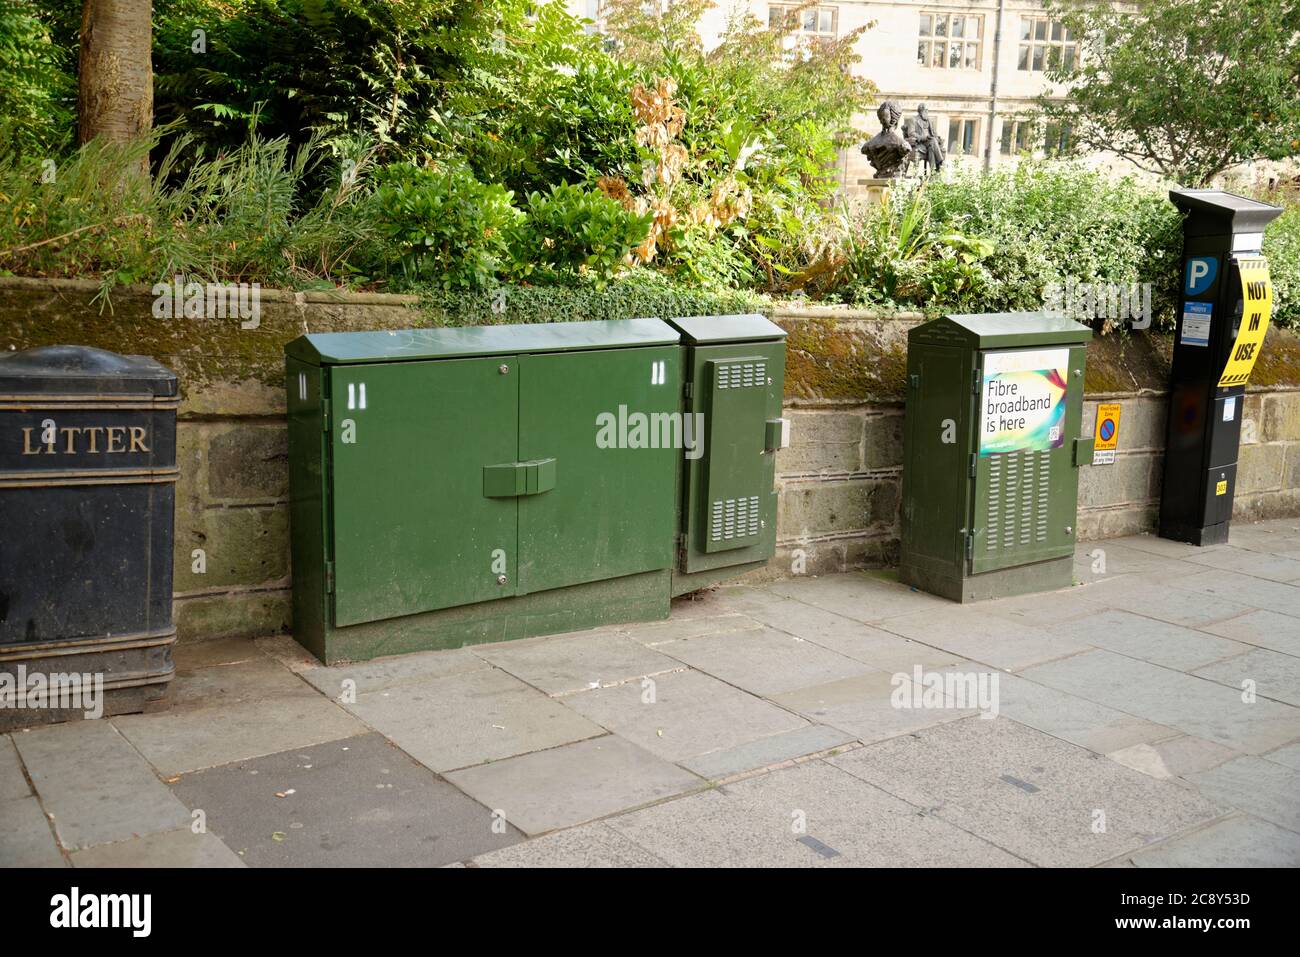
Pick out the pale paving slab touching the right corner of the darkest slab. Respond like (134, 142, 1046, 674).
(447, 735, 705, 835)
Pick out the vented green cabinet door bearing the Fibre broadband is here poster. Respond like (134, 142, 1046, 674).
(971, 346, 1086, 573)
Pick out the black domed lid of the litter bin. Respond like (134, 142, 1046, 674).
(0, 346, 177, 395)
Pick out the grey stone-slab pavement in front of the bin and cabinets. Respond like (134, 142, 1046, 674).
(0, 520, 1300, 867)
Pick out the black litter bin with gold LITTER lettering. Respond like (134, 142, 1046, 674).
(0, 346, 179, 731)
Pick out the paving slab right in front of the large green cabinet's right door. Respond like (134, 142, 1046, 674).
(476, 632, 681, 696)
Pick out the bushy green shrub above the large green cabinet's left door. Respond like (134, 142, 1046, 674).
(374, 164, 520, 289)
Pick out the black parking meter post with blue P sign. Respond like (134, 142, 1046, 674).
(1160, 190, 1282, 545)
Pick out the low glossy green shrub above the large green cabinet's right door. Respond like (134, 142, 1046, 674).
(514, 183, 654, 286)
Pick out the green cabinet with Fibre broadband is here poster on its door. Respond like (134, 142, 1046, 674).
(900, 313, 1092, 601)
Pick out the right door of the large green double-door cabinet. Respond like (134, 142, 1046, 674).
(519, 346, 683, 594)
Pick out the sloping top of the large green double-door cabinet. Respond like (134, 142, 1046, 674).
(285, 319, 680, 365)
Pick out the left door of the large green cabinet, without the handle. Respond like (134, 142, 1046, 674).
(328, 356, 519, 625)
